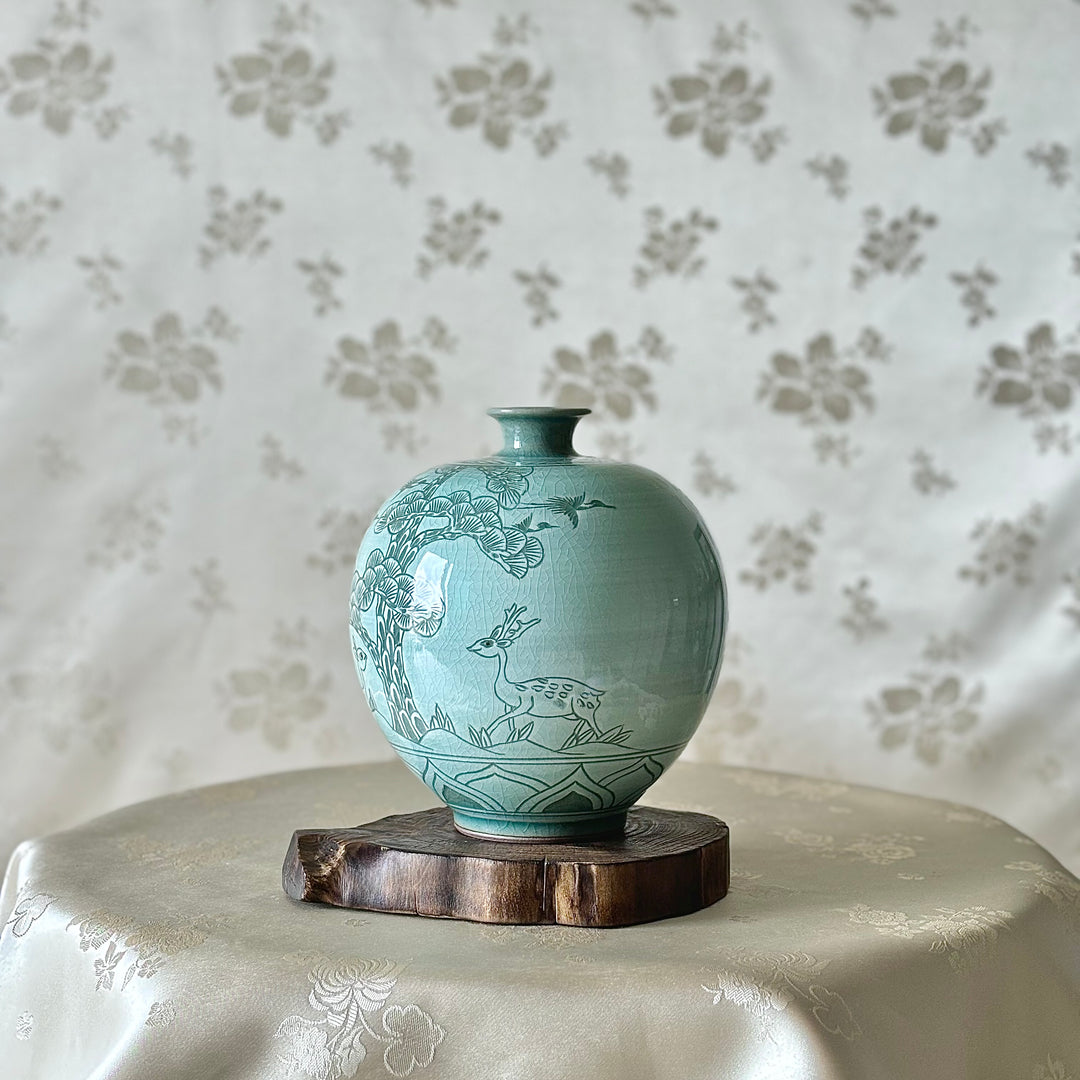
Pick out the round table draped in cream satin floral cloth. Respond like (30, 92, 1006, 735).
(0, 762, 1080, 1080)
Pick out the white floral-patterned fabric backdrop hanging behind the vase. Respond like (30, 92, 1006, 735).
(0, 0, 1080, 869)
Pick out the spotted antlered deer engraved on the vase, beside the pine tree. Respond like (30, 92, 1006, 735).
(469, 605, 604, 747)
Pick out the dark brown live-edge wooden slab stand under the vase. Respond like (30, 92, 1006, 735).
(282, 807, 729, 927)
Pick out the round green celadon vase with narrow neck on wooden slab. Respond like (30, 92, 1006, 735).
(350, 407, 727, 840)
